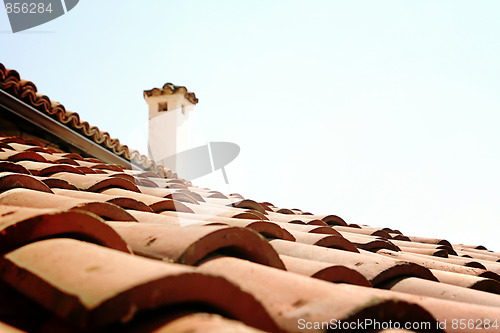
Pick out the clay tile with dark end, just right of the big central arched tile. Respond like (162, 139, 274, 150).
(280, 255, 372, 287)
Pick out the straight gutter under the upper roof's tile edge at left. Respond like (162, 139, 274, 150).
(0, 89, 137, 169)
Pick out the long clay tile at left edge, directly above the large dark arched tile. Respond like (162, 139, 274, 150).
(0, 188, 136, 221)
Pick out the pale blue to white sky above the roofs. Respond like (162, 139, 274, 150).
(0, 0, 500, 251)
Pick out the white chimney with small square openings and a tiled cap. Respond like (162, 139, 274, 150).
(144, 83, 198, 161)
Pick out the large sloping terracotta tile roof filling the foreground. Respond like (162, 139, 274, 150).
(0, 64, 500, 332)
